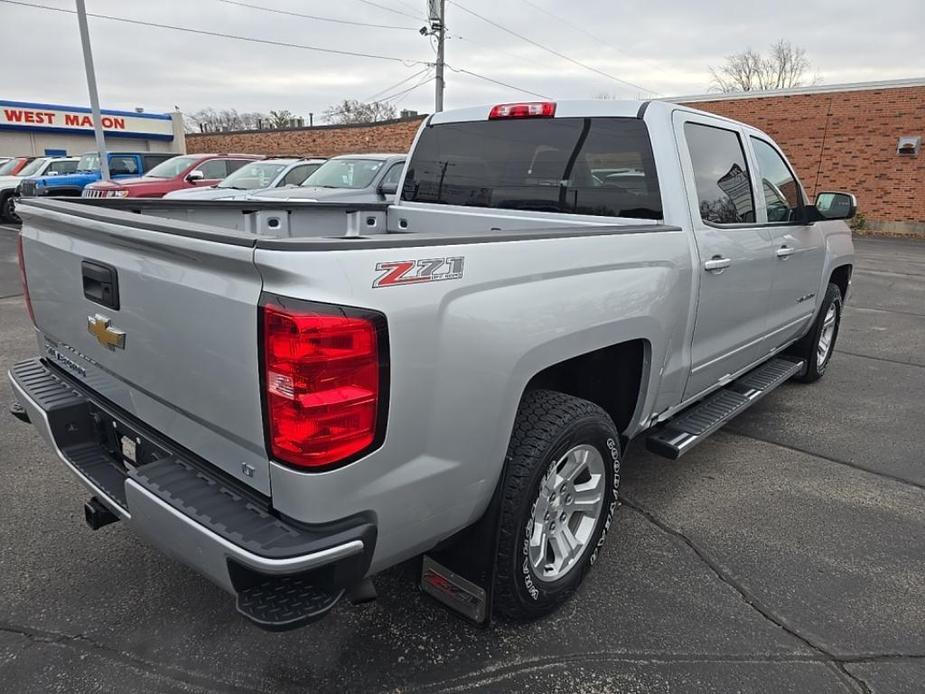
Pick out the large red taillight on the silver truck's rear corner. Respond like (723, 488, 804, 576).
(262, 298, 388, 469)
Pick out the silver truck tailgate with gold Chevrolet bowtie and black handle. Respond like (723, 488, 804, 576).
(21, 205, 270, 495)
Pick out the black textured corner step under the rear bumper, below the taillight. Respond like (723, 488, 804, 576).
(237, 576, 344, 631)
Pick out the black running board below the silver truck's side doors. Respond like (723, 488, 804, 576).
(646, 358, 803, 460)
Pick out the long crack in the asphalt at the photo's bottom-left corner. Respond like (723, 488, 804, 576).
(0, 622, 274, 694)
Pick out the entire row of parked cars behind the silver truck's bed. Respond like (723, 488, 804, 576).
(0, 152, 405, 222)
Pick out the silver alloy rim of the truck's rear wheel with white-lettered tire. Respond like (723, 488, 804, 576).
(528, 444, 606, 583)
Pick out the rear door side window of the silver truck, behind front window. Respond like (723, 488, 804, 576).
(684, 123, 755, 224)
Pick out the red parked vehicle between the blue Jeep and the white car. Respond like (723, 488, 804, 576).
(83, 154, 264, 198)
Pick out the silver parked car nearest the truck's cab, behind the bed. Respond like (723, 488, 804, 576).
(247, 154, 407, 203)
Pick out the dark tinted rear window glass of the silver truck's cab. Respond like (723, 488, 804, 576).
(402, 118, 662, 219)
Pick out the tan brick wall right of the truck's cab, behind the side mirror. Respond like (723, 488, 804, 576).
(688, 87, 925, 223)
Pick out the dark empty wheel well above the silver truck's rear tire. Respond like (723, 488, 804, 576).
(525, 340, 645, 433)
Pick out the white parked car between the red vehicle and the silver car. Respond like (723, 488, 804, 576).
(164, 159, 325, 200)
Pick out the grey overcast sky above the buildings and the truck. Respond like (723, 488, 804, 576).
(0, 0, 925, 122)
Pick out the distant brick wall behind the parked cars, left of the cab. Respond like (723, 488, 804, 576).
(186, 118, 422, 157)
